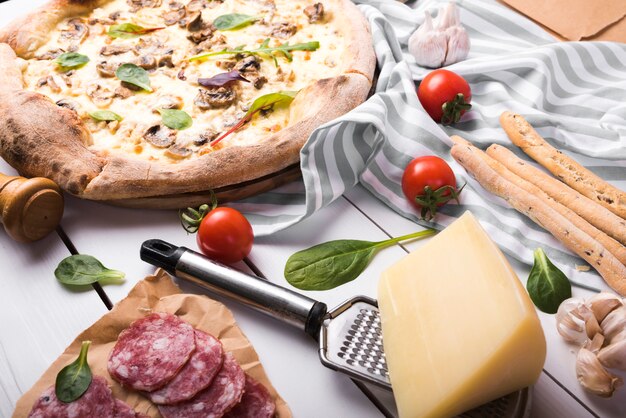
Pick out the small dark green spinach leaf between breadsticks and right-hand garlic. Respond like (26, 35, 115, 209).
(526, 248, 572, 314)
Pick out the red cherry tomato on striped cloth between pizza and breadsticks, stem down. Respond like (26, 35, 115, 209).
(402, 155, 460, 219)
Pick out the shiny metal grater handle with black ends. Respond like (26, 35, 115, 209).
(140, 239, 327, 340)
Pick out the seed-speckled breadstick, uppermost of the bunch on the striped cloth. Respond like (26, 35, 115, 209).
(500, 112, 626, 219)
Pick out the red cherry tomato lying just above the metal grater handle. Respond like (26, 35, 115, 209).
(197, 207, 254, 264)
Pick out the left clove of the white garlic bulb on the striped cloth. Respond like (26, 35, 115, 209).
(409, 12, 448, 68)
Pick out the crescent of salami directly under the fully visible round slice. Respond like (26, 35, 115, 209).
(146, 330, 224, 404)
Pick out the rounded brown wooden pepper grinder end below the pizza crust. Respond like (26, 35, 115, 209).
(0, 173, 63, 242)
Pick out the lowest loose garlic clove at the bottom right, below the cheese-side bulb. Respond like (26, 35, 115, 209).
(576, 348, 623, 398)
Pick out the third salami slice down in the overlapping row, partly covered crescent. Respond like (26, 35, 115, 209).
(159, 353, 246, 418)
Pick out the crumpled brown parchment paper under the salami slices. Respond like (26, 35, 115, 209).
(13, 269, 291, 418)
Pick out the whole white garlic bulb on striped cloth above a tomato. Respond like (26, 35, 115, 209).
(409, 2, 470, 68)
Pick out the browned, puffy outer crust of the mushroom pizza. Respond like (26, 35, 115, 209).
(0, 0, 375, 206)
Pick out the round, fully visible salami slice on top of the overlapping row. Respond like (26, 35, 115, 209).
(108, 313, 196, 391)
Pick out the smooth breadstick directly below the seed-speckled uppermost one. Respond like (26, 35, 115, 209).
(487, 144, 626, 245)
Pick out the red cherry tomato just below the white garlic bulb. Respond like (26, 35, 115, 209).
(417, 70, 472, 124)
